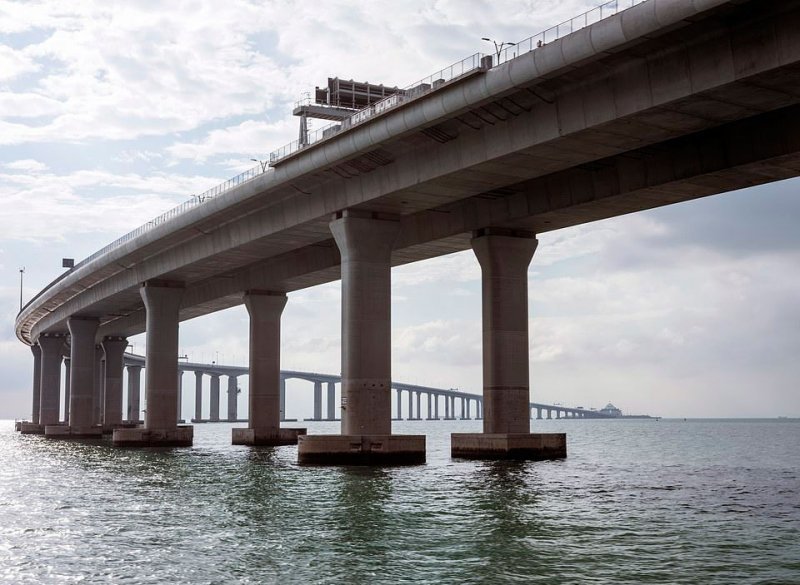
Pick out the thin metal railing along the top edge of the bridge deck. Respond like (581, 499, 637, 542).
(23, 0, 647, 310)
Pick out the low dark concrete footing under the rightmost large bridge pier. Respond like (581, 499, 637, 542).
(450, 433, 567, 461)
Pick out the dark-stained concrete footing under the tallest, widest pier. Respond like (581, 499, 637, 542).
(297, 435, 425, 465)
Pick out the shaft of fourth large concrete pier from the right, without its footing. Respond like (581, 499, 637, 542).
(139, 283, 183, 430)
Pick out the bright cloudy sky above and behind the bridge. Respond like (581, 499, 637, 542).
(0, 0, 800, 418)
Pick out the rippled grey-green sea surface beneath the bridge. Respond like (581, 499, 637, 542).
(0, 420, 800, 584)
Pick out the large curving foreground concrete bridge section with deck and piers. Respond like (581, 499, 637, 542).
(16, 0, 800, 464)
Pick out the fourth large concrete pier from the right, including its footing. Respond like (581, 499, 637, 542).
(113, 282, 193, 446)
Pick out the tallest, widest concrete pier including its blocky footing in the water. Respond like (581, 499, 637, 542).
(298, 210, 425, 464)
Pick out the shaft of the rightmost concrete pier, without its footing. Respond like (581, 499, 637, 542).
(472, 235, 537, 433)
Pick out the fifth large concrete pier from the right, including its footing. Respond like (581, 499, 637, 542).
(44, 317, 103, 438)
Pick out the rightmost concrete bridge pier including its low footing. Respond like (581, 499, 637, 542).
(451, 228, 566, 459)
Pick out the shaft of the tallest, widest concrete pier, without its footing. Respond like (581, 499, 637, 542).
(331, 215, 400, 435)
